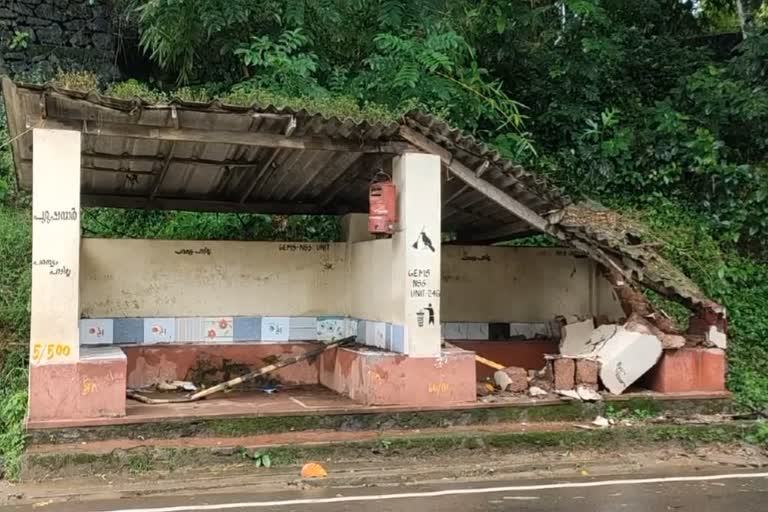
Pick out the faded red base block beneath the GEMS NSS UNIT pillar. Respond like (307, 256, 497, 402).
(320, 348, 476, 407)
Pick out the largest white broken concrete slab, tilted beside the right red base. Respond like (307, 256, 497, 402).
(597, 327, 662, 395)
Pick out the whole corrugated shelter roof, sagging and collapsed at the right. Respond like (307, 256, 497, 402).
(3, 78, 724, 315)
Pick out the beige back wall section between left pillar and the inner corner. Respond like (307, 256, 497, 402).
(80, 239, 347, 317)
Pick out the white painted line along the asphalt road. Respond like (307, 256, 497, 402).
(91, 473, 768, 512)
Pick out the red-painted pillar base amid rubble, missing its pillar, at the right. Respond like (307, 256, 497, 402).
(645, 348, 726, 393)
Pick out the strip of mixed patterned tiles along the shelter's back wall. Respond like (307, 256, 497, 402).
(80, 316, 559, 353)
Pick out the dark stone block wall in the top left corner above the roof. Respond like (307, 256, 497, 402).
(0, 0, 119, 82)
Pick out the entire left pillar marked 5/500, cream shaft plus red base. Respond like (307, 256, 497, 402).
(27, 128, 126, 426)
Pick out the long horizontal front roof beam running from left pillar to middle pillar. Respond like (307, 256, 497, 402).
(39, 118, 410, 154)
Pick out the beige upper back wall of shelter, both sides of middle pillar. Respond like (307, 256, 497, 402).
(80, 239, 621, 322)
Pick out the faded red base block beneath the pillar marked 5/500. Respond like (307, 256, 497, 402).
(27, 347, 127, 427)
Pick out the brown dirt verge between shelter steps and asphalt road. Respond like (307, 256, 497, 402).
(0, 444, 768, 509)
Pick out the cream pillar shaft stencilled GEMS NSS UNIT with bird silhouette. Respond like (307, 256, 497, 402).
(392, 153, 441, 356)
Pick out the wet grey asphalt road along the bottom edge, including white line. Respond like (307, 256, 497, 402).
(0, 472, 768, 512)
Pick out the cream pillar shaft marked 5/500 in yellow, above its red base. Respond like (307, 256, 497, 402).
(30, 129, 80, 366)
